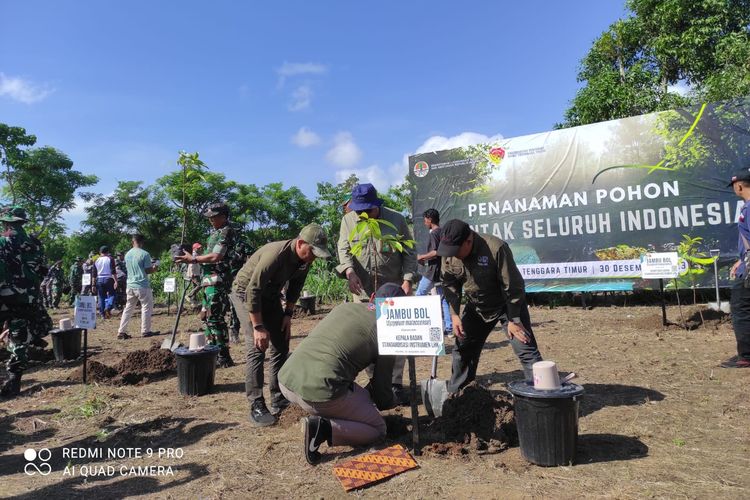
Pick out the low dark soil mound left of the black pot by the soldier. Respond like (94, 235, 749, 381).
(68, 346, 177, 385)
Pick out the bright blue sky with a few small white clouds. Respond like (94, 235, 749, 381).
(0, 0, 625, 229)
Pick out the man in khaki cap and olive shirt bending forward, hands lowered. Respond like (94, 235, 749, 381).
(232, 224, 331, 427)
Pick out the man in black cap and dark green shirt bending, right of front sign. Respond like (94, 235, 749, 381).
(437, 219, 542, 392)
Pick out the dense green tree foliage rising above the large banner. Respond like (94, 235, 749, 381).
(556, 0, 750, 128)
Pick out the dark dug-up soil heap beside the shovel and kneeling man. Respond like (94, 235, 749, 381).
(420, 382, 518, 456)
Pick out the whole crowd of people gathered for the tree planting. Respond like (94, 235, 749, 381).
(0, 176, 750, 464)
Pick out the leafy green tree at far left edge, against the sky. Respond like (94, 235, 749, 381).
(3, 146, 99, 236)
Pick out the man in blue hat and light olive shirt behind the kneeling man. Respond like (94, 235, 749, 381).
(336, 184, 418, 403)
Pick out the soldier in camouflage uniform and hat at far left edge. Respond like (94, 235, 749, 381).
(0, 207, 47, 397)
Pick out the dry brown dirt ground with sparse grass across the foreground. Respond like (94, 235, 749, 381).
(0, 298, 750, 499)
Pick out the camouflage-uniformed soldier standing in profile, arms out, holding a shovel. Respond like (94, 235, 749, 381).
(175, 203, 236, 367)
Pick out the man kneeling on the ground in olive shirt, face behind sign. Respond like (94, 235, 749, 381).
(279, 283, 404, 465)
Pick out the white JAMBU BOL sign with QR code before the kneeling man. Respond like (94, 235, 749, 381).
(375, 295, 445, 356)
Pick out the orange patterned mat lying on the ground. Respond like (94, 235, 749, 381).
(333, 444, 419, 491)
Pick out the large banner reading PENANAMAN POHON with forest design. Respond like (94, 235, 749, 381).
(409, 98, 750, 291)
